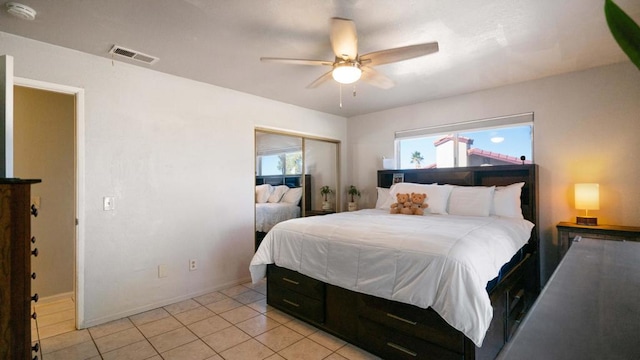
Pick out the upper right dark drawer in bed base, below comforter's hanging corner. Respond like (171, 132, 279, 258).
(358, 294, 465, 349)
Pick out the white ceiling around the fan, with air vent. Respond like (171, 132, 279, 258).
(0, 0, 640, 117)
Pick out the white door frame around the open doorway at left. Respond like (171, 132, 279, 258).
(13, 76, 85, 329)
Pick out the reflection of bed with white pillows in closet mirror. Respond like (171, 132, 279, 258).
(255, 175, 311, 249)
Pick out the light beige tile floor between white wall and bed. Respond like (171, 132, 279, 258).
(33, 282, 379, 360)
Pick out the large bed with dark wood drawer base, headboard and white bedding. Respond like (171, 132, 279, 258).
(250, 165, 539, 359)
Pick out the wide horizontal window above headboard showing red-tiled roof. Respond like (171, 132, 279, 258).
(395, 113, 533, 169)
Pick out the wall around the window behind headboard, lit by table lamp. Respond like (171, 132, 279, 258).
(347, 63, 640, 280)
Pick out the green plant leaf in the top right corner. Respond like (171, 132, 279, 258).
(604, 0, 640, 70)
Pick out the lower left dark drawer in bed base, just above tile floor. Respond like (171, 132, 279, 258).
(267, 284, 325, 324)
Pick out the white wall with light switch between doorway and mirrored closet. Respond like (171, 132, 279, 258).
(0, 33, 346, 326)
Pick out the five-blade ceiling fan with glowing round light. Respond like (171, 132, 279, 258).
(260, 18, 438, 89)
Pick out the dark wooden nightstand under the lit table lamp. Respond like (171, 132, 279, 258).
(556, 222, 640, 260)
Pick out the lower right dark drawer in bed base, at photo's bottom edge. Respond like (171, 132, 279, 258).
(358, 318, 464, 360)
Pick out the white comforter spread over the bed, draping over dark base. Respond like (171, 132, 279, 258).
(250, 210, 533, 346)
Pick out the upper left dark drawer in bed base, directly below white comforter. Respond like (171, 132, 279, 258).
(267, 265, 325, 301)
